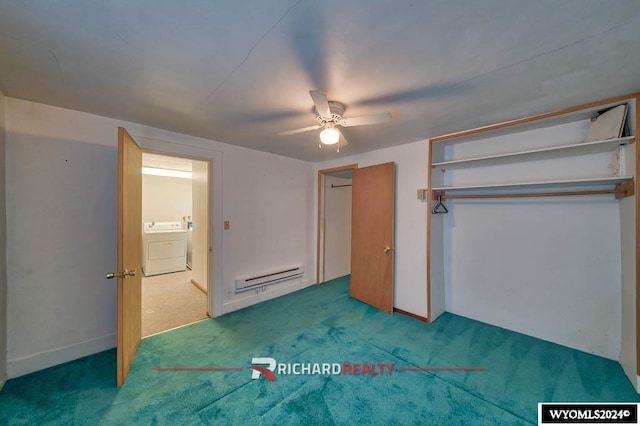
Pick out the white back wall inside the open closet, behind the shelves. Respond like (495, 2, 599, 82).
(443, 121, 621, 359)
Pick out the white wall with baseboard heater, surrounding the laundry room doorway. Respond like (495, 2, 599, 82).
(6, 98, 315, 377)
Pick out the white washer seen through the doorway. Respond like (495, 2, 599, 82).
(142, 222, 187, 277)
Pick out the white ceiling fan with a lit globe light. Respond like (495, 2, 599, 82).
(278, 90, 391, 152)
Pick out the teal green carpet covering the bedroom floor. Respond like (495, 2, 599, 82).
(0, 277, 640, 425)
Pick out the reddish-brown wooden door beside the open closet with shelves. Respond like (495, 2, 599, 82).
(351, 163, 395, 313)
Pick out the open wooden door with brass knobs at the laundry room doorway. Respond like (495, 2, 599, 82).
(107, 127, 142, 386)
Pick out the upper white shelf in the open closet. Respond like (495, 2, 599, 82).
(431, 136, 635, 170)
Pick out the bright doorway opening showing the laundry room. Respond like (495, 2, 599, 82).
(142, 152, 210, 337)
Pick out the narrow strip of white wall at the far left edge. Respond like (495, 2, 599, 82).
(0, 92, 7, 389)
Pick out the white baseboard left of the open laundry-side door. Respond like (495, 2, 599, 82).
(7, 334, 116, 379)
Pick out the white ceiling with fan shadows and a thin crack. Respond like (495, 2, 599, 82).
(0, 0, 640, 161)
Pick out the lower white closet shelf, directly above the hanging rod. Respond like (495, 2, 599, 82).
(431, 176, 633, 194)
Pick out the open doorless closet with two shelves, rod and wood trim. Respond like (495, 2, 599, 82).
(427, 93, 640, 389)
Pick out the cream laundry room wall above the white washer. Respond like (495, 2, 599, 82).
(142, 174, 192, 223)
